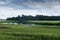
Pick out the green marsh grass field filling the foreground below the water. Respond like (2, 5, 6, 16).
(0, 21, 60, 40)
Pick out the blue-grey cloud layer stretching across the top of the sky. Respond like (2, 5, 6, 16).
(0, 0, 60, 9)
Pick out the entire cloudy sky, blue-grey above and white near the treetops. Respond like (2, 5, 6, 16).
(0, 0, 60, 19)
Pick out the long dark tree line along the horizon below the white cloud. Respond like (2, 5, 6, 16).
(7, 15, 60, 21)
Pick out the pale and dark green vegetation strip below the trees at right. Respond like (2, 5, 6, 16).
(28, 21, 60, 26)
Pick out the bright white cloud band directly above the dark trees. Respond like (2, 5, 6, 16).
(0, 7, 60, 19)
